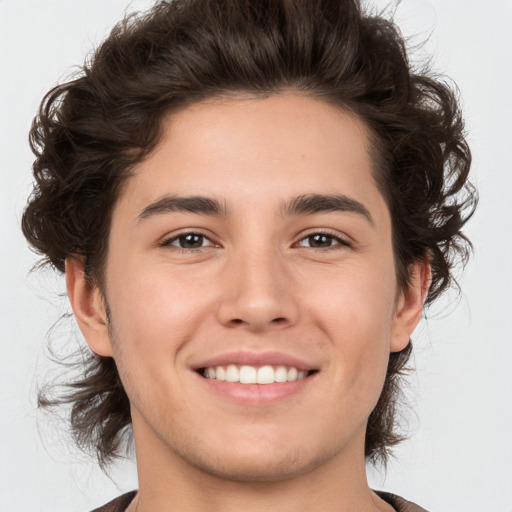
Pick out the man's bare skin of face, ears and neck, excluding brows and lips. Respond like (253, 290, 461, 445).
(66, 94, 429, 512)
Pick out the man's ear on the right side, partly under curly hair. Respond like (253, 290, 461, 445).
(390, 261, 432, 352)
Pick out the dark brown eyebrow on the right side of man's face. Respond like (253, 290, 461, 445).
(282, 194, 374, 226)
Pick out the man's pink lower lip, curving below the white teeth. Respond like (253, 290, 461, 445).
(198, 373, 316, 407)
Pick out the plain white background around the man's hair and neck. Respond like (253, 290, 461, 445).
(0, 0, 512, 512)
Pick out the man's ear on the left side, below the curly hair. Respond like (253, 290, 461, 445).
(66, 256, 112, 357)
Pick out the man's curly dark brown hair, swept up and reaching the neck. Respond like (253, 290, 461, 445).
(22, 0, 476, 465)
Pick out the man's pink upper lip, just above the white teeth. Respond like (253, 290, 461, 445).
(193, 350, 317, 371)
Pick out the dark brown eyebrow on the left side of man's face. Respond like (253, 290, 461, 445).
(138, 196, 228, 220)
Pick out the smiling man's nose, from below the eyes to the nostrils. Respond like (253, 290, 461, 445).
(217, 248, 299, 332)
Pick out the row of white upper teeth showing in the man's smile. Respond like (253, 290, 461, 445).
(204, 364, 308, 384)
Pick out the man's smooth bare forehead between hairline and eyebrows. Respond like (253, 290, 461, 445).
(115, 94, 388, 221)
